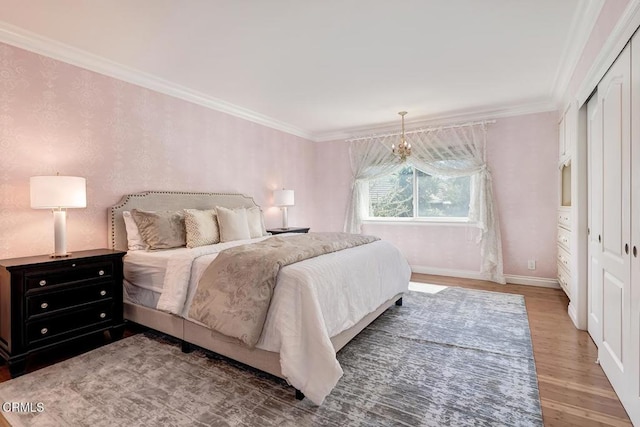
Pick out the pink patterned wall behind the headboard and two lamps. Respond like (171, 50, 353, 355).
(0, 44, 315, 258)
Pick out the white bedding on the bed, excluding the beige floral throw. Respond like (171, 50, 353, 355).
(125, 235, 411, 404)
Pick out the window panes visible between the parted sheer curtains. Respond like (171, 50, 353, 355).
(369, 166, 471, 219)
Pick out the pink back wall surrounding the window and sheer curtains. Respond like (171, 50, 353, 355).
(314, 112, 558, 278)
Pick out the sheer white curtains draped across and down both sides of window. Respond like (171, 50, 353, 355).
(345, 123, 505, 283)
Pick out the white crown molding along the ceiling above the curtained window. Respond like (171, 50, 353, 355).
(313, 101, 558, 142)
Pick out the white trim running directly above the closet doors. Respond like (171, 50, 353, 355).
(564, 0, 640, 106)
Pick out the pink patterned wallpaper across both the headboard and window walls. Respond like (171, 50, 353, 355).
(0, 44, 558, 278)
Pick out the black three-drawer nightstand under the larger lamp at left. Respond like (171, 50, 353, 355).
(0, 249, 126, 377)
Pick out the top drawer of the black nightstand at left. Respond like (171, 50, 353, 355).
(25, 262, 113, 289)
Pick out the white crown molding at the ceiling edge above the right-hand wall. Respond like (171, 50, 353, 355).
(550, 0, 605, 103)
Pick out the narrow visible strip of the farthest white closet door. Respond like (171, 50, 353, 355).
(587, 92, 603, 347)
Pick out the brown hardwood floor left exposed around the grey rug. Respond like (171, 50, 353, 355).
(0, 274, 631, 427)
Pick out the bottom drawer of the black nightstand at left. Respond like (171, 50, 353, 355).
(27, 301, 113, 346)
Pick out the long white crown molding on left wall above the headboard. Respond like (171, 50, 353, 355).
(0, 21, 313, 140)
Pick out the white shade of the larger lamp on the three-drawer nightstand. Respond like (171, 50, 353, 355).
(30, 176, 87, 209)
